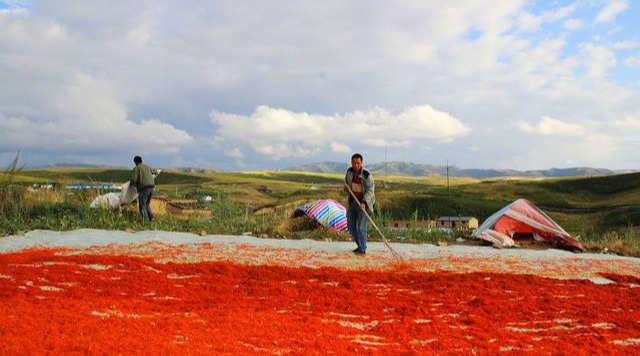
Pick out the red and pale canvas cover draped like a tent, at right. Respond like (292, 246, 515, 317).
(472, 199, 584, 251)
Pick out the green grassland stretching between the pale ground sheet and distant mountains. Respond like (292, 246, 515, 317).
(0, 165, 640, 256)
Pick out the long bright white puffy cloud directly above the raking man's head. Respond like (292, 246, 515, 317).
(210, 105, 470, 158)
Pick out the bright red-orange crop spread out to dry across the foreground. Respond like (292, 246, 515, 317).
(0, 250, 640, 355)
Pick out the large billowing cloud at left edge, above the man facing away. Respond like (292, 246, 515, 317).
(0, 73, 192, 154)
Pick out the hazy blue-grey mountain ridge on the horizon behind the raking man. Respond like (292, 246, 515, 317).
(282, 162, 635, 178)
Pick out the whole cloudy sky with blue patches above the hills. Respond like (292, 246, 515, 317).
(0, 0, 640, 170)
